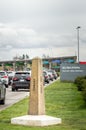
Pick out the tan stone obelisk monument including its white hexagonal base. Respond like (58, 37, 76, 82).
(11, 57, 61, 126)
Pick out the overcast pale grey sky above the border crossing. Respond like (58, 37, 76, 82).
(0, 0, 86, 61)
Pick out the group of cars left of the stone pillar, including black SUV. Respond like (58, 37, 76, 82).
(0, 71, 31, 105)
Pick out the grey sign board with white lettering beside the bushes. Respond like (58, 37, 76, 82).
(60, 63, 86, 82)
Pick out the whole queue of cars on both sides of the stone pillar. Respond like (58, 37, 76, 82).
(0, 70, 58, 104)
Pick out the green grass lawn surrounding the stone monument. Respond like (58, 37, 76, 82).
(0, 81, 86, 130)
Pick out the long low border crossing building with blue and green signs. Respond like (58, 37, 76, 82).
(0, 56, 77, 71)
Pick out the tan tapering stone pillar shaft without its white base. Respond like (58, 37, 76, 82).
(29, 57, 45, 115)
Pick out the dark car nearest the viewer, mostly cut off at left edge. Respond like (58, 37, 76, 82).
(0, 79, 6, 105)
